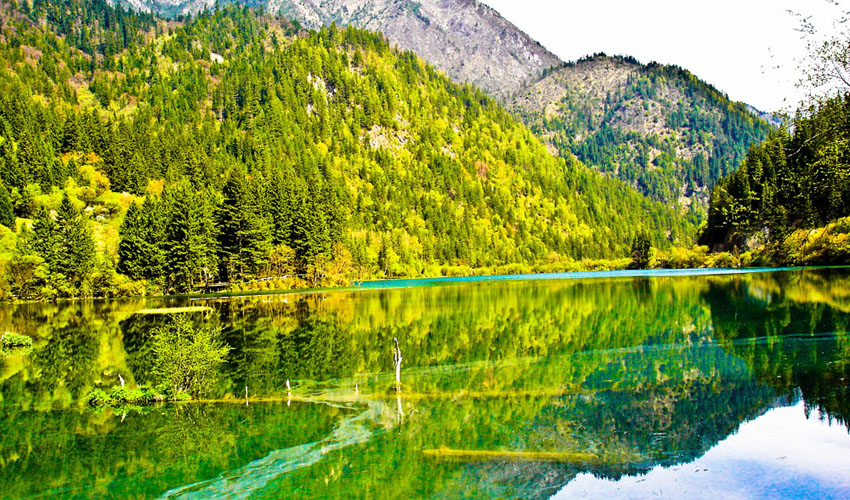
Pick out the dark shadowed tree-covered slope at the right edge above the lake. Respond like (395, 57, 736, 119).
(700, 93, 850, 264)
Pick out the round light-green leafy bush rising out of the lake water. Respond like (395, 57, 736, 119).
(153, 314, 230, 398)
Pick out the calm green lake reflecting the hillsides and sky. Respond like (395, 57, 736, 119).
(0, 268, 850, 499)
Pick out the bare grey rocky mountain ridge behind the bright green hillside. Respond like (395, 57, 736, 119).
(112, 0, 561, 98)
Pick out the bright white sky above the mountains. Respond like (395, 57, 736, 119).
(482, 0, 850, 111)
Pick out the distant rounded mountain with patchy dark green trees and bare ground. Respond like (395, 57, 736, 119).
(511, 54, 770, 212)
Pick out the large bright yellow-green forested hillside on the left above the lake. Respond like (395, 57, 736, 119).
(0, 0, 692, 298)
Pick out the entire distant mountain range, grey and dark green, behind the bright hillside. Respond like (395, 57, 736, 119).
(112, 0, 770, 211)
